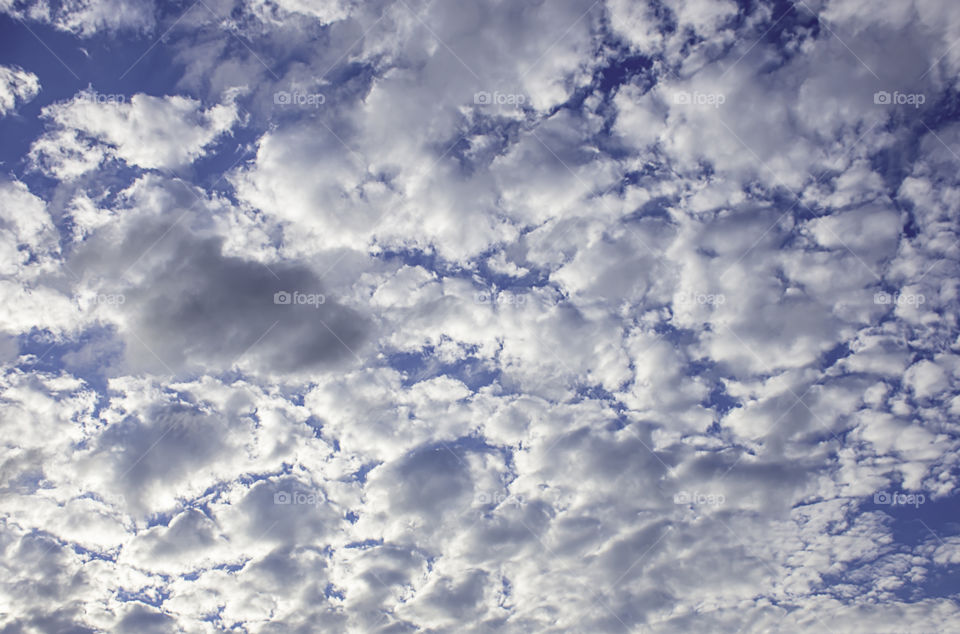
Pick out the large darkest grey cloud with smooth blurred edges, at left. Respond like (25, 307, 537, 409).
(70, 216, 370, 374)
